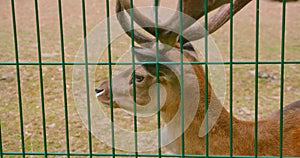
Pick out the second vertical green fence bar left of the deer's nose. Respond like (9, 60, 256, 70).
(58, 0, 70, 157)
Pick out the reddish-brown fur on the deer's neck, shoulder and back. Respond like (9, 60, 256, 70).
(99, 48, 300, 156)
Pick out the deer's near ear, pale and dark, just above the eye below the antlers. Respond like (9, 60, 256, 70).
(134, 47, 179, 78)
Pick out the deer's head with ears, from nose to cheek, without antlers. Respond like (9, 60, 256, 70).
(95, 43, 204, 118)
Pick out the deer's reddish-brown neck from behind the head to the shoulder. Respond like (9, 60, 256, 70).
(161, 59, 254, 154)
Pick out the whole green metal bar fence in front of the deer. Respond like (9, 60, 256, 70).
(0, 0, 300, 158)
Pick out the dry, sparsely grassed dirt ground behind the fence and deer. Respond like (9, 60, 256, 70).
(0, 0, 300, 157)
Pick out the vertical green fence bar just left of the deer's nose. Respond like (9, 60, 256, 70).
(81, 0, 93, 157)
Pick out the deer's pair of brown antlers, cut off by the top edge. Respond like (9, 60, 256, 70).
(118, 0, 251, 46)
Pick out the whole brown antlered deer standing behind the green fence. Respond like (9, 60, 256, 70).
(95, 0, 300, 156)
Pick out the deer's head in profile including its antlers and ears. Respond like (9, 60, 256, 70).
(95, 0, 251, 111)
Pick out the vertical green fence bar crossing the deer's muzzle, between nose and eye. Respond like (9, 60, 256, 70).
(106, 0, 116, 157)
